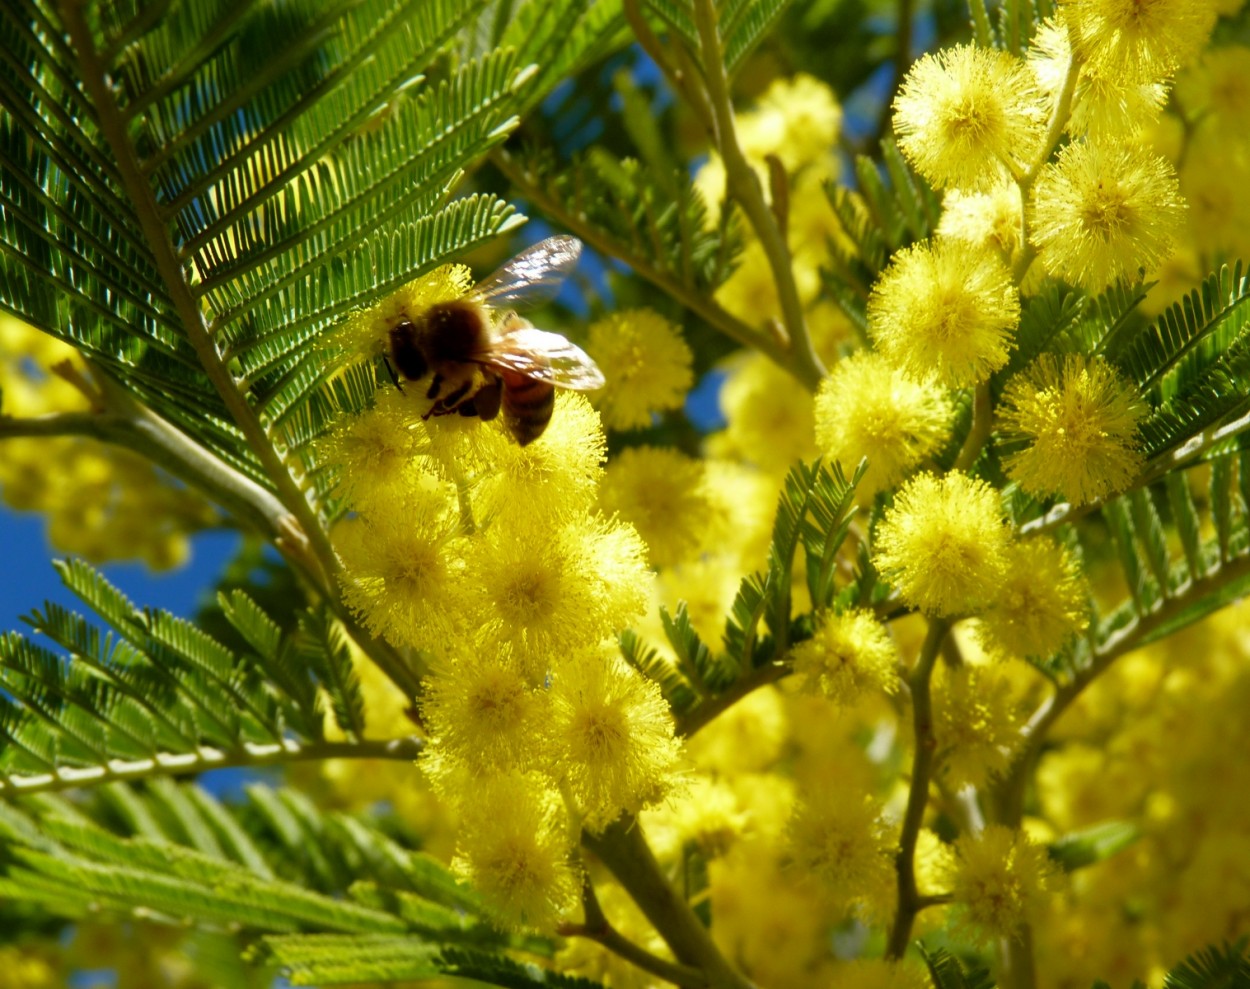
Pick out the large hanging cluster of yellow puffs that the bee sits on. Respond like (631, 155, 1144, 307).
(323, 270, 679, 929)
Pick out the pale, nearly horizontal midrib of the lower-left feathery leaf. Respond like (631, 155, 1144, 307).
(0, 736, 424, 796)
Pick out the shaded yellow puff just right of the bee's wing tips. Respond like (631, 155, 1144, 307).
(586, 309, 694, 429)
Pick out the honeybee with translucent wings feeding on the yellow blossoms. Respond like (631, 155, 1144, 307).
(386, 236, 604, 446)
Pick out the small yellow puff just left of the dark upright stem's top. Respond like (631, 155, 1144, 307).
(794, 610, 899, 706)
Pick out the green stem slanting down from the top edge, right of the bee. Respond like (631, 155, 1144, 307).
(694, 0, 825, 381)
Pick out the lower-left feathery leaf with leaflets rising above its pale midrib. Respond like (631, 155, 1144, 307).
(0, 563, 410, 795)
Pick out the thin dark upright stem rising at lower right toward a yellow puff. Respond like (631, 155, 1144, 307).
(885, 618, 950, 959)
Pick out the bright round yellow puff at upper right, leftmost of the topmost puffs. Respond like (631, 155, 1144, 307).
(894, 45, 1046, 191)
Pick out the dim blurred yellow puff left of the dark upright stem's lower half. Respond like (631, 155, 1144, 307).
(789, 790, 895, 918)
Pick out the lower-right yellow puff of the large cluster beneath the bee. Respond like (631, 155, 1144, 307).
(550, 653, 681, 831)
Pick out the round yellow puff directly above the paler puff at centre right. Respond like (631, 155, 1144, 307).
(868, 240, 1020, 388)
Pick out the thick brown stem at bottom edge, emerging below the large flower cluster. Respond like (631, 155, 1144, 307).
(581, 815, 754, 989)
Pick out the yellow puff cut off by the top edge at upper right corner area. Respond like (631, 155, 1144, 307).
(1059, 0, 1216, 83)
